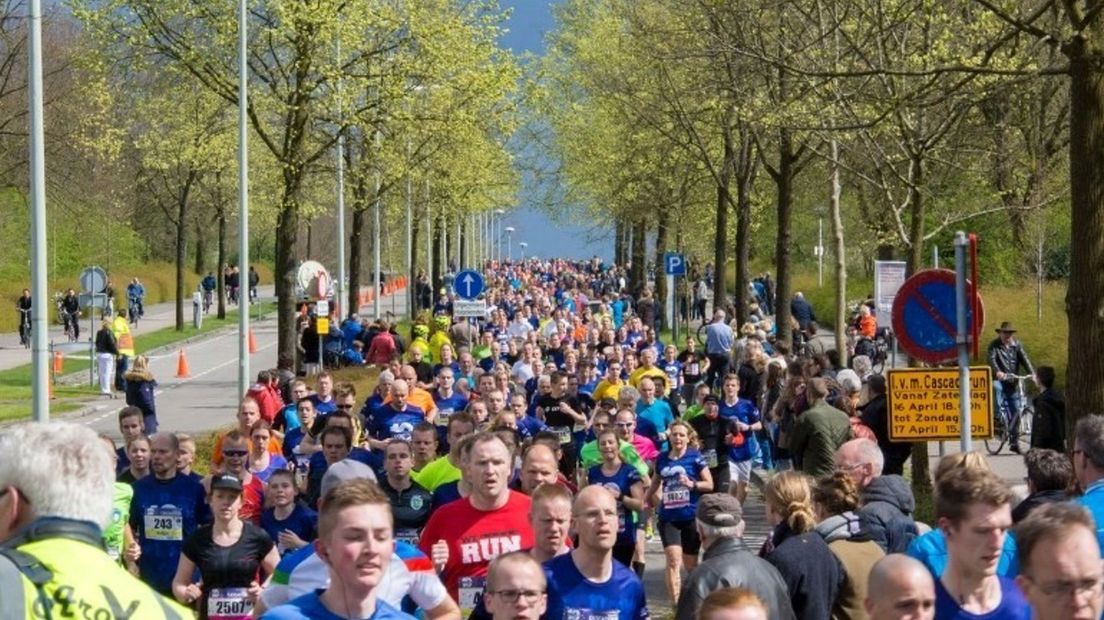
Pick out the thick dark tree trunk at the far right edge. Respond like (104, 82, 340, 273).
(1065, 36, 1104, 437)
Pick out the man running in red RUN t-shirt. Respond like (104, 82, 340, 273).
(420, 432, 533, 618)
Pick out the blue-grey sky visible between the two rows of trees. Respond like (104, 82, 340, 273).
(500, 0, 613, 260)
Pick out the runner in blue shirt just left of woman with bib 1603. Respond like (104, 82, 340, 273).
(586, 429, 644, 567)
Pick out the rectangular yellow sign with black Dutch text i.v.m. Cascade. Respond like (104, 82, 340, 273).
(885, 366, 992, 441)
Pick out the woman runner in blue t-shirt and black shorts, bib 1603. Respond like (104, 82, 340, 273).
(647, 420, 713, 601)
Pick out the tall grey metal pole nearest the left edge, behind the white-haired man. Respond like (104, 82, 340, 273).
(26, 0, 50, 421)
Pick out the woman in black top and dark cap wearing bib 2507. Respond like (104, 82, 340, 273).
(172, 473, 279, 620)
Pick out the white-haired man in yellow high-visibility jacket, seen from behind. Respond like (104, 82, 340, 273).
(0, 423, 191, 620)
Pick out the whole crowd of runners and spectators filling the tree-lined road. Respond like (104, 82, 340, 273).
(0, 259, 1104, 620)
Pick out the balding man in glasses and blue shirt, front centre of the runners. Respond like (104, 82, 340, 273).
(544, 485, 649, 620)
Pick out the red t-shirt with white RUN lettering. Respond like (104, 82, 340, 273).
(418, 491, 534, 617)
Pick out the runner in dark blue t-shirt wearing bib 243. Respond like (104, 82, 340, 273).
(130, 432, 211, 596)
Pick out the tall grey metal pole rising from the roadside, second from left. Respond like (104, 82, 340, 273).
(237, 0, 249, 395)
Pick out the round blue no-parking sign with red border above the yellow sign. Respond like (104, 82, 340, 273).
(893, 269, 985, 364)
